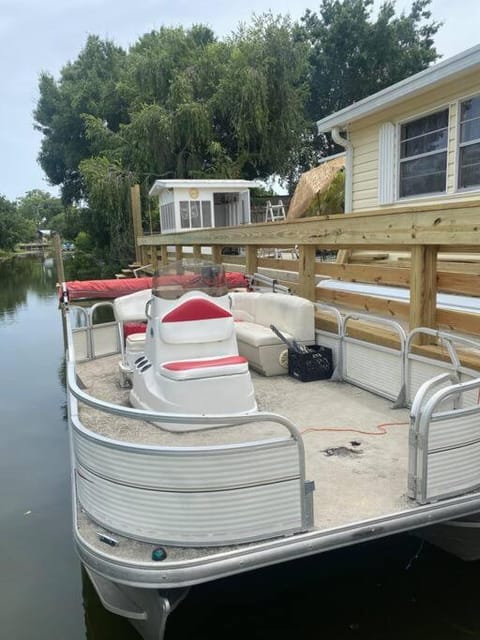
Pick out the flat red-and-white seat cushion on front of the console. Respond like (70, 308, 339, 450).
(160, 355, 248, 380)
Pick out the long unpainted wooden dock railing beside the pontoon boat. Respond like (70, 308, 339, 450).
(136, 199, 480, 334)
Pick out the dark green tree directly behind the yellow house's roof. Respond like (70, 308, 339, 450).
(299, 0, 441, 120)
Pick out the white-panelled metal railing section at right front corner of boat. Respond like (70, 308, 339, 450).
(408, 372, 480, 504)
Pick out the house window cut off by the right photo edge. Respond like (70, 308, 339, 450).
(458, 96, 480, 189)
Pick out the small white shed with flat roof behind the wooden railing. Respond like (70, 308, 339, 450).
(149, 180, 257, 233)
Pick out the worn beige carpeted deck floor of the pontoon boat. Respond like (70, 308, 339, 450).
(77, 355, 417, 560)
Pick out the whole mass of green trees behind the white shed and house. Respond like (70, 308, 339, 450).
(32, 0, 439, 268)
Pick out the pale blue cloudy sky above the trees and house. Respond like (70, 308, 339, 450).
(0, 0, 480, 201)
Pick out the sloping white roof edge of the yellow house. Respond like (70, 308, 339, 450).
(317, 45, 480, 133)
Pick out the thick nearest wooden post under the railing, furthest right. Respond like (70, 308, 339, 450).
(409, 245, 437, 338)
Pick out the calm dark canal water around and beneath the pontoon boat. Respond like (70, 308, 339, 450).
(0, 252, 480, 640)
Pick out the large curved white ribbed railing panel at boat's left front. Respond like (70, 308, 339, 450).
(67, 312, 313, 546)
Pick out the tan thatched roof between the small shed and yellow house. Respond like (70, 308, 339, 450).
(287, 154, 345, 220)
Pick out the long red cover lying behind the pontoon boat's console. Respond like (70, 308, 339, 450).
(59, 271, 248, 300)
